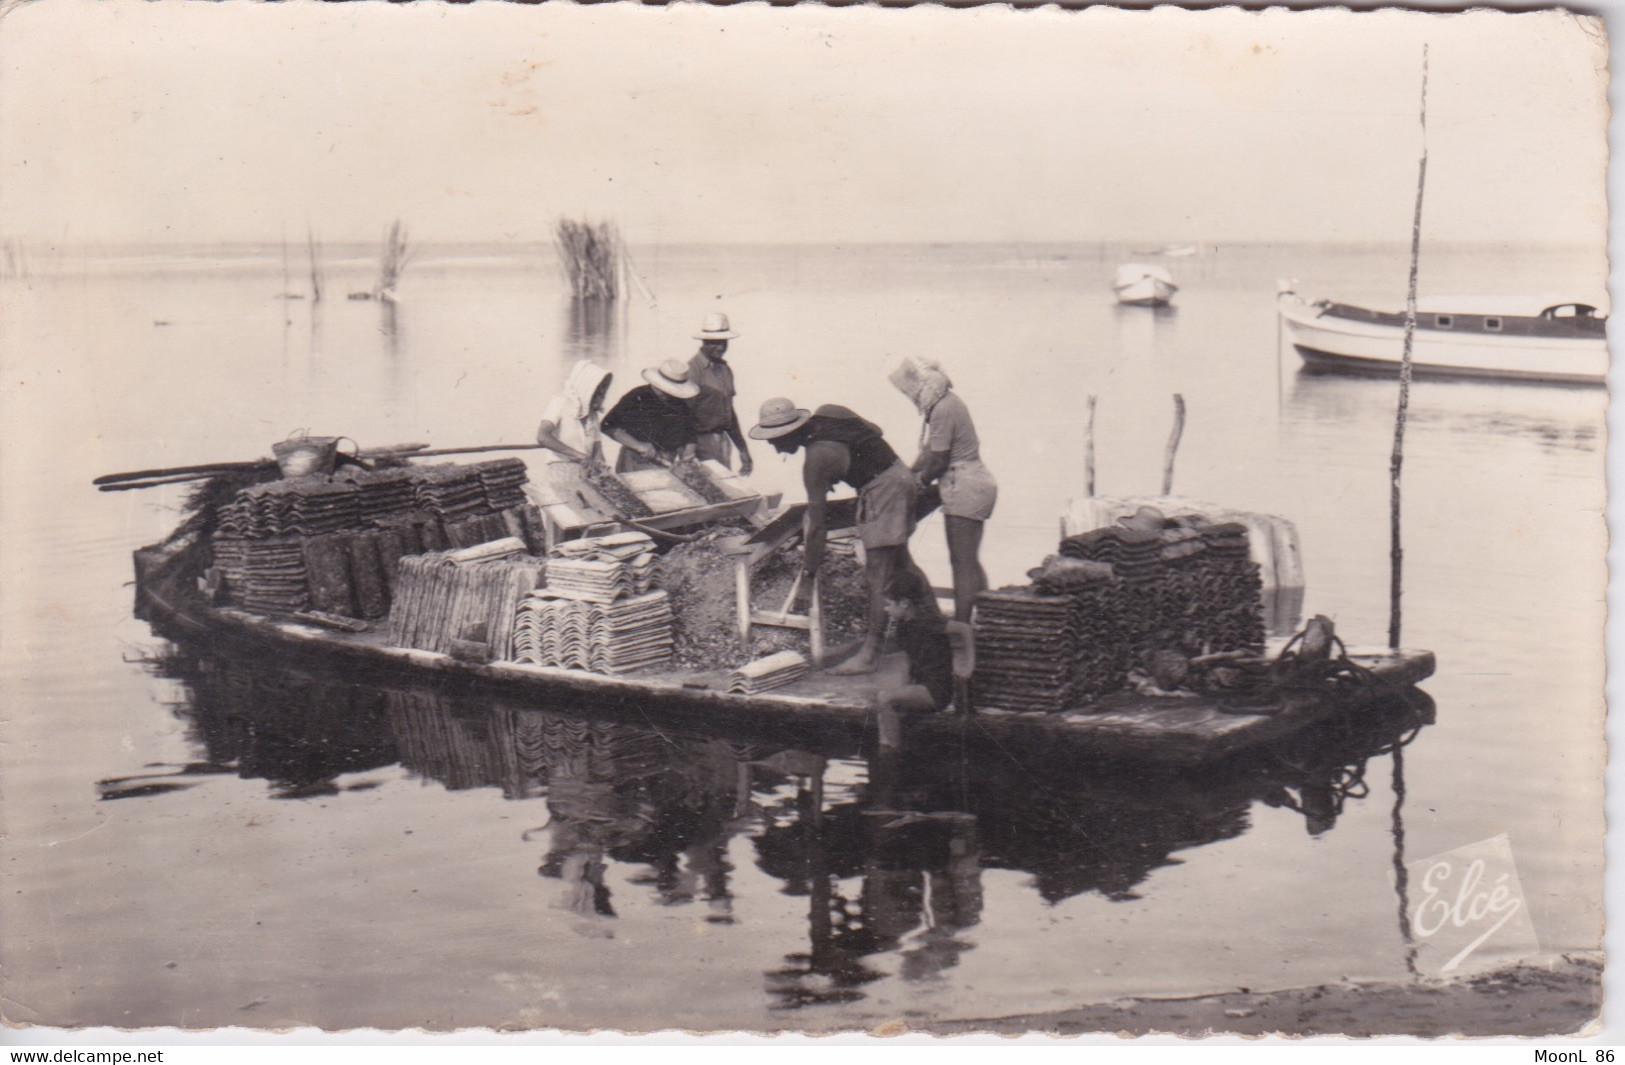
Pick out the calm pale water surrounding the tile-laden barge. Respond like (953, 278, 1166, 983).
(0, 239, 1606, 1029)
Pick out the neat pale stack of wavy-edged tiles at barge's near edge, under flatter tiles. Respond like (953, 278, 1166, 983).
(514, 591, 673, 675)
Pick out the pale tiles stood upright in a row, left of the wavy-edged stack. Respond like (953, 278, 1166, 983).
(388, 551, 546, 660)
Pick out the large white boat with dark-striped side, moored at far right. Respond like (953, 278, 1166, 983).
(1279, 285, 1609, 385)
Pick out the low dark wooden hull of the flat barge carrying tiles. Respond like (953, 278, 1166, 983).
(137, 548, 1433, 764)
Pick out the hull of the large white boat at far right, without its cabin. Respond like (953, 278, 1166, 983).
(1281, 298, 1609, 385)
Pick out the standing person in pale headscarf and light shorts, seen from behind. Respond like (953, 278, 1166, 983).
(891, 358, 999, 621)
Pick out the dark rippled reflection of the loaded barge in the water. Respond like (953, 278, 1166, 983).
(136, 647, 1435, 1008)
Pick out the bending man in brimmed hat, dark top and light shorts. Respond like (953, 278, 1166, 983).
(751, 398, 936, 673)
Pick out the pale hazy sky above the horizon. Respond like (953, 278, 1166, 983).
(0, 0, 1607, 242)
